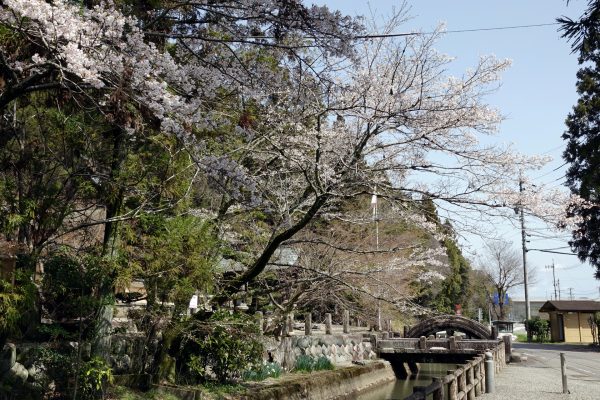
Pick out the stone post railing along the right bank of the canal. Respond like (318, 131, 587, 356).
(405, 341, 506, 400)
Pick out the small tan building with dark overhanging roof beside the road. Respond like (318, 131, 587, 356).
(539, 300, 600, 343)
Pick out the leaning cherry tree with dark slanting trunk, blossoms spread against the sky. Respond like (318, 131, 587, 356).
(209, 15, 559, 304)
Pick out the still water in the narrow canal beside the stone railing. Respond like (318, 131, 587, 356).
(356, 363, 456, 400)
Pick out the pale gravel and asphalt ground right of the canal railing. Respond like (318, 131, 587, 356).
(480, 343, 600, 400)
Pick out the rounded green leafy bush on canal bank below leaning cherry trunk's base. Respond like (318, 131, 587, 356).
(171, 312, 263, 383)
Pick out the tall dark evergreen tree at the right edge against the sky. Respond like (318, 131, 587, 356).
(558, 0, 600, 279)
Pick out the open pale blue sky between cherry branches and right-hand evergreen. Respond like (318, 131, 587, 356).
(315, 0, 600, 299)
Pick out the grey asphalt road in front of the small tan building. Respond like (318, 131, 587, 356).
(513, 343, 600, 382)
